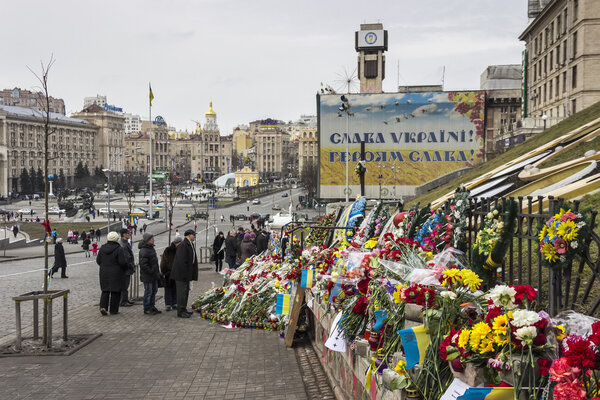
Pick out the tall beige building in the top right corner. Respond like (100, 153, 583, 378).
(519, 0, 600, 119)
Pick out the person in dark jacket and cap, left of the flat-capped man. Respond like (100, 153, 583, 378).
(138, 233, 162, 315)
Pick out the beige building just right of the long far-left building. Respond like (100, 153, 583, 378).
(72, 104, 125, 172)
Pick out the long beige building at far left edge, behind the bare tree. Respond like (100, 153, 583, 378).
(0, 105, 100, 196)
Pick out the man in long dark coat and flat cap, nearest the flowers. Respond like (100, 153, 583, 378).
(171, 229, 198, 318)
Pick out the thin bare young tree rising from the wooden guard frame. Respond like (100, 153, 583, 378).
(27, 55, 56, 343)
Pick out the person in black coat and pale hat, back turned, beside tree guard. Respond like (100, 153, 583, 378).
(96, 232, 127, 315)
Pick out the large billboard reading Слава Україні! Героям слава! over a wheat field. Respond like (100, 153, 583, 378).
(317, 91, 485, 199)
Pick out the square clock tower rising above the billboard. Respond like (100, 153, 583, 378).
(354, 24, 387, 93)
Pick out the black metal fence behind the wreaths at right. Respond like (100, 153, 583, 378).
(467, 196, 600, 316)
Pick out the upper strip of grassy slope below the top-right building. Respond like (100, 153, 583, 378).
(406, 102, 600, 207)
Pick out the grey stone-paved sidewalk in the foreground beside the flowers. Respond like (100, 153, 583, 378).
(0, 265, 333, 400)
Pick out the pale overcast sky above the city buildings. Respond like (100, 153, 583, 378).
(0, 0, 527, 135)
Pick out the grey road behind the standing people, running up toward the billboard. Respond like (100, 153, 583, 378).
(0, 189, 315, 339)
